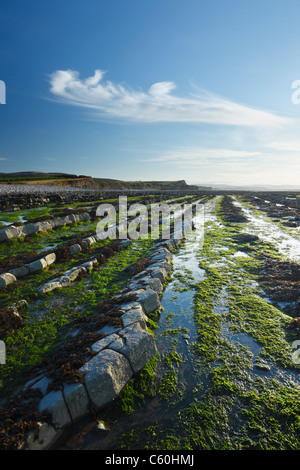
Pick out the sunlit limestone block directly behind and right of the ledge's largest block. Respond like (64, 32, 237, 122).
(109, 329, 157, 374)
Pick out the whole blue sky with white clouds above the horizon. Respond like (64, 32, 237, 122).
(0, 0, 300, 187)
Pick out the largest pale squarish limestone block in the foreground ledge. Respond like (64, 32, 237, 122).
(79, 349, 132, 408)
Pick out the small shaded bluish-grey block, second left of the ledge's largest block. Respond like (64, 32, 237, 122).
(39, 390, 71, 428)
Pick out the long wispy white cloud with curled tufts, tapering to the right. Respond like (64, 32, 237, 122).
(49, 70, 290, 128)
